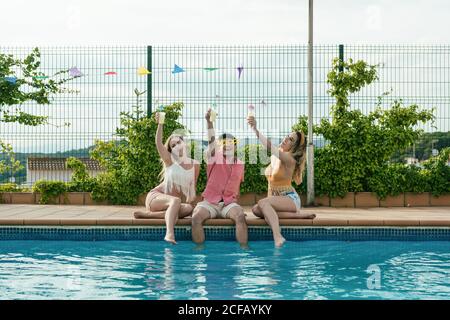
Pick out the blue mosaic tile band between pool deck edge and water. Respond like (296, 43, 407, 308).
(0, 226, 450, 242)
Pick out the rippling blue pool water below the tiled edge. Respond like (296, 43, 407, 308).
(0, 241, 450, 299)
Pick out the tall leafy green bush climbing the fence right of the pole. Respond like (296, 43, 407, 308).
(293, 59, 434, 197)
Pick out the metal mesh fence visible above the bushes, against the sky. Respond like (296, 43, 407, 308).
(0, 45, 450, 183)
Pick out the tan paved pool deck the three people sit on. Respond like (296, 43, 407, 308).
(0, 204, 450, 227)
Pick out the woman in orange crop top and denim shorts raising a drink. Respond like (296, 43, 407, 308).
(247, 116, 315, 247)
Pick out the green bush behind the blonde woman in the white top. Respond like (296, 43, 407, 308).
(91, 103, 185, 204)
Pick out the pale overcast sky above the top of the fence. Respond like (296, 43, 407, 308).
(0, 0, 450, 45)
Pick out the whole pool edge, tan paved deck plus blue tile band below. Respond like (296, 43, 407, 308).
(0, 204, 450, 240)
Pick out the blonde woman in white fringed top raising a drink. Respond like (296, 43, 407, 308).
(134, 113, 200, 244)
